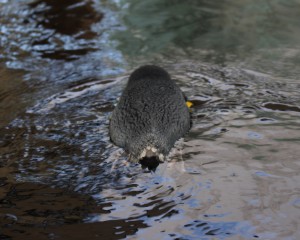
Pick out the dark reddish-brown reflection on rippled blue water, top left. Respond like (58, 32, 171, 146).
(25, 0, 103, 60)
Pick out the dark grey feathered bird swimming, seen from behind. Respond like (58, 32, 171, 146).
(109, 65, 190, 165)
